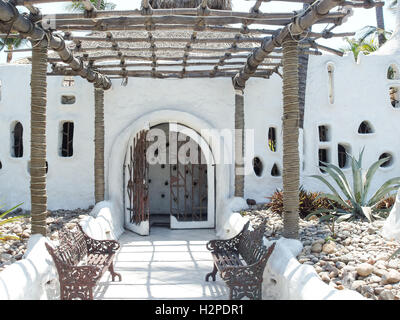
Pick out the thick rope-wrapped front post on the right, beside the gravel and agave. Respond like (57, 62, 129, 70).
(282, 35, 300, 239)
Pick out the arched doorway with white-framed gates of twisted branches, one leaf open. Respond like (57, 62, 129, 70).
(124, 123, 215, 235)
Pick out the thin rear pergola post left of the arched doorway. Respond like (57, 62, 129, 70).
(94, 88, 104, 203)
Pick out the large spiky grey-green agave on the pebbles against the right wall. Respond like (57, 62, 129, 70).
(306, 149, 400, 222)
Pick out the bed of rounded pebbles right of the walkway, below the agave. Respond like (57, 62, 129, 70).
(241, 209, 400, 300)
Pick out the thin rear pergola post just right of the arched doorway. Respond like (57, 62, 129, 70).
(235, 90, 244, 197)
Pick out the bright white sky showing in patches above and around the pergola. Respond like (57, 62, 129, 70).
(0, 0, 395, 63)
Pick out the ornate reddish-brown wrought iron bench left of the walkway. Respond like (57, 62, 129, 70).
(46, 224, 121, 300)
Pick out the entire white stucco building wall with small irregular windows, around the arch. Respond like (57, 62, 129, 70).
(0, 48, 400, 232)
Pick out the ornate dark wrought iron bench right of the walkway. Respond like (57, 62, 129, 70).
(206, 222, 275, 300)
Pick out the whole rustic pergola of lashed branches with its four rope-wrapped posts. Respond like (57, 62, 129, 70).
(0, 0, 384, 238)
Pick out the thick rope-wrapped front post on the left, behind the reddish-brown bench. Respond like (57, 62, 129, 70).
(30, 40, 47, 236)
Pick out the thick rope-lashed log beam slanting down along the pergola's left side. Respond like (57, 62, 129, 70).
(0, 0, 111, 90)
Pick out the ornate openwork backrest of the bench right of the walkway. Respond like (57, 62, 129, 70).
(238, 222, 266, 264)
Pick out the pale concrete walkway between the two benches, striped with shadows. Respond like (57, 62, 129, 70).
(94, 227, 228, 300)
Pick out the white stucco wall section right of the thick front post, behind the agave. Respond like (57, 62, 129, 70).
(303, 53, 400, 195)
